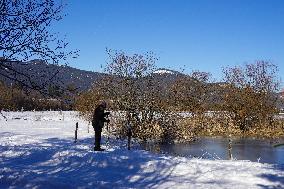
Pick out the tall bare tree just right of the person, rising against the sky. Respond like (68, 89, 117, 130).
(99, 50, 166, 140)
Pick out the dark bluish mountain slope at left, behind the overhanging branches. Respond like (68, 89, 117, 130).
(0, 60, 105, 91)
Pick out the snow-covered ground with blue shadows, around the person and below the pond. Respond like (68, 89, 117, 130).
(0, 112, 284, 189)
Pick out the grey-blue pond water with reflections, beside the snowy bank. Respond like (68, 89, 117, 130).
(145, 137, 284, 164)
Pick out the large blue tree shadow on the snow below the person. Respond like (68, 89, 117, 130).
(0, 133, 183, 188)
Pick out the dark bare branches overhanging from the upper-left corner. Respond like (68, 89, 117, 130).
(0, 0, 77, 93)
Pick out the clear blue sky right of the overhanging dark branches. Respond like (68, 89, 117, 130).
(55, 0, 284, 85)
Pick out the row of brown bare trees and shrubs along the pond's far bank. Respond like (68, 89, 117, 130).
(75, 50, 284, 142)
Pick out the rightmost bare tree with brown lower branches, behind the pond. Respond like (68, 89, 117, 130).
(223, 61, 279, 130)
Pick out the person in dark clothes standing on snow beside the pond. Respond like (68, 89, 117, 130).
(92, 101, 110, 151)
